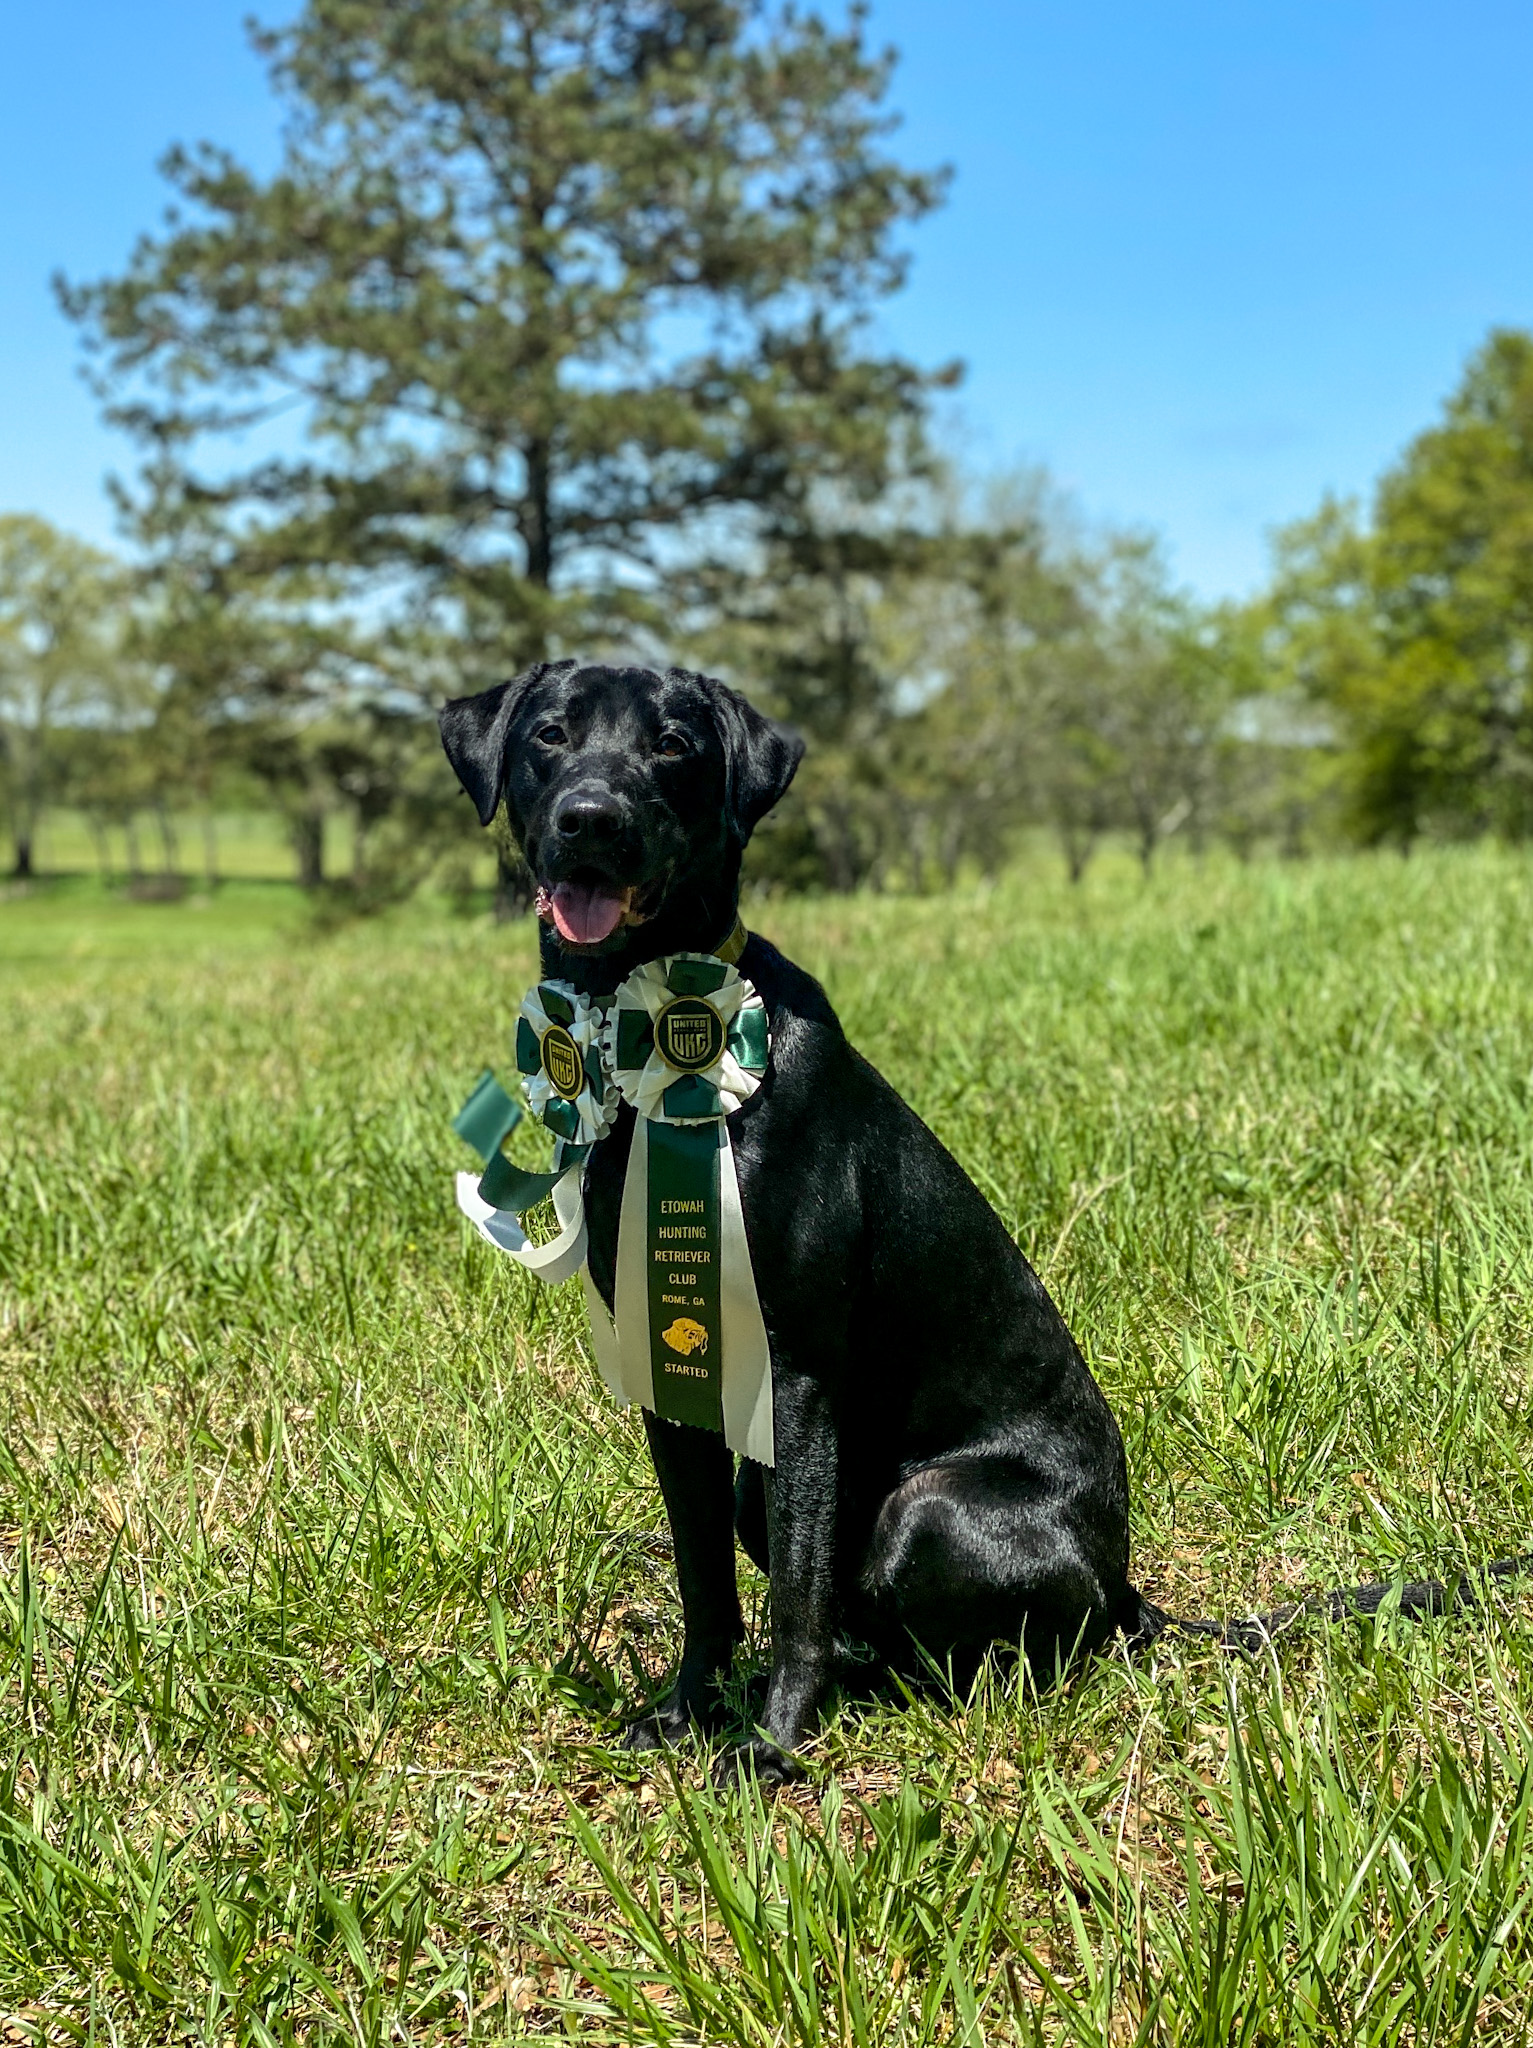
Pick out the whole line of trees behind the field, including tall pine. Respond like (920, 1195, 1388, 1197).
(0, 0, 1533, 901)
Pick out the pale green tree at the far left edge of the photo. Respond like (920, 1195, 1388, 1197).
(0, 514, 129, 879)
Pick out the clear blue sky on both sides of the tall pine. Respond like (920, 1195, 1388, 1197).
(0, 0, 1533, 596)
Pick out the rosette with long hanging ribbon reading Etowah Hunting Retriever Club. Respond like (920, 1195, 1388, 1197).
(605, 952, 774, 1464)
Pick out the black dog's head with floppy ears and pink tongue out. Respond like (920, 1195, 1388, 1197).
(440, 662, 804, 952)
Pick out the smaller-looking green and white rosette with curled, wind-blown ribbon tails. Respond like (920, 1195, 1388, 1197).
(452, 981, 618, 1286)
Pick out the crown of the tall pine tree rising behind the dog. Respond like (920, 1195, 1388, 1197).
(63, 0, 941, 686)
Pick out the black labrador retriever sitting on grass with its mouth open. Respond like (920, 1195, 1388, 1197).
(442, 662, 1165, 1780)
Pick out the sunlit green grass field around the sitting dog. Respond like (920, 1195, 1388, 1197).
(0, 850, 1533, 2048)
